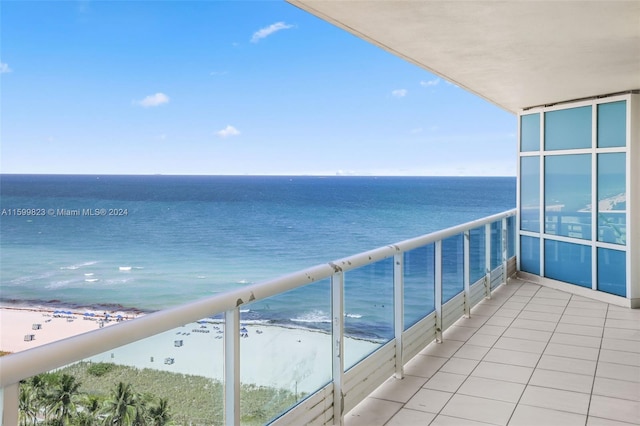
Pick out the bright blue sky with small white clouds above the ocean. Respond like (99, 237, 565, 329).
(0, 1, 516, 176)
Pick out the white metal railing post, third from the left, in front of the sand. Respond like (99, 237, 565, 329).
(331, 272, 344, 425)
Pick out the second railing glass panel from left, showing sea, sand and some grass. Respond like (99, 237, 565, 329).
(240, 279, 332, 424)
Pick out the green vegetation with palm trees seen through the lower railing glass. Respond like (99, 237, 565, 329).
(19, 362, 304, 426)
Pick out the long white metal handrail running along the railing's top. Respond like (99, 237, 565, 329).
(0, 209, 516, 422)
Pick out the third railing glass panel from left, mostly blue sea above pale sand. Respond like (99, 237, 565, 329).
(344, 258, 393, 370)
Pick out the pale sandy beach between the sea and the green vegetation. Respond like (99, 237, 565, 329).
(0, 307, 379, 392)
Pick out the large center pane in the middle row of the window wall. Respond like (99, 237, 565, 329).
(544, 154, 591, 240)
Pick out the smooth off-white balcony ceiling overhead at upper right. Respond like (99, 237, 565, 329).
(287, 0, 640, 112)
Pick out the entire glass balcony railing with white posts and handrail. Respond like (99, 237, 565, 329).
(0, 210, 516, 426)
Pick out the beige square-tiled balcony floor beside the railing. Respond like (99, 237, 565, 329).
(345, 279, 640, 426)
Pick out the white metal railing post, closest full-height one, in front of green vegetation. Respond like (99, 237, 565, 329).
(224, 308, 240, 426)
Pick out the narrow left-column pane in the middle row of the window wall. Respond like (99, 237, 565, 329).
(520, 156, 540, 232)
